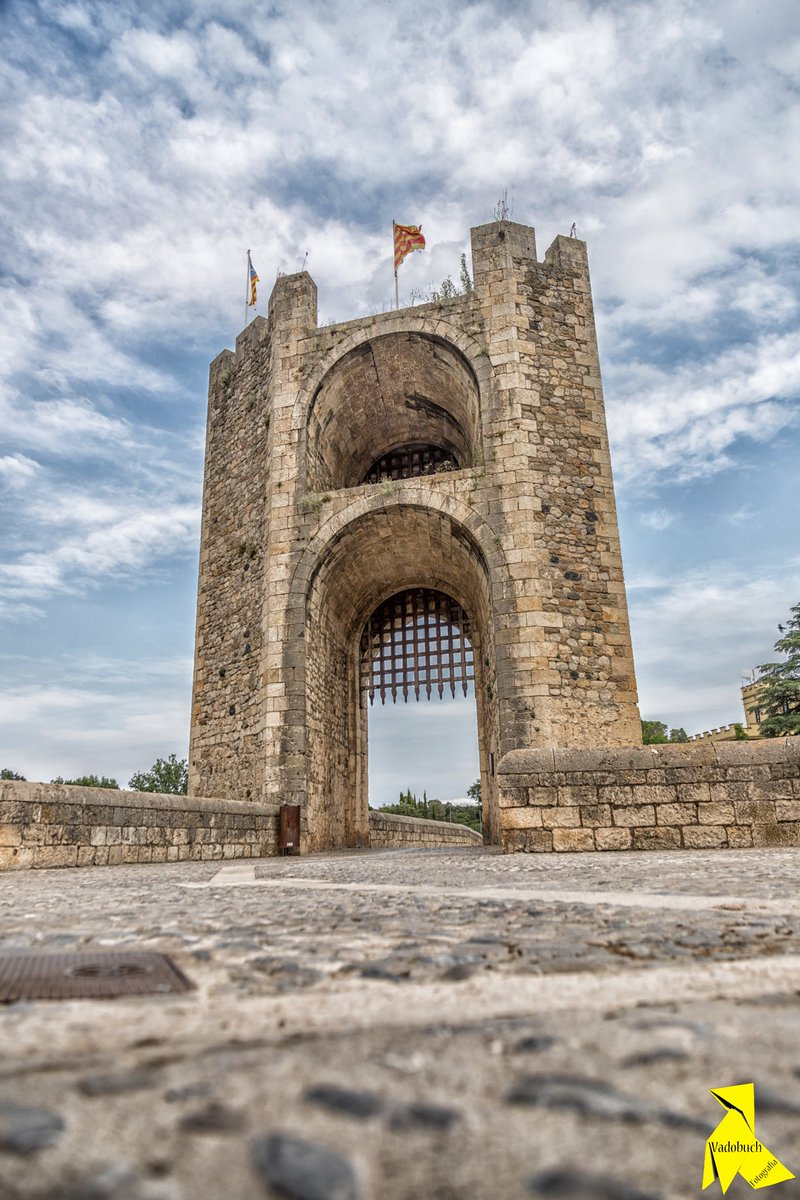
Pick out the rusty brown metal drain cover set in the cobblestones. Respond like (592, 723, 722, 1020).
(0, 950, 193, 1004)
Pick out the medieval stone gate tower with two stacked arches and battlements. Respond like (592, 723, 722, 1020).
(190, 221, 640, 850)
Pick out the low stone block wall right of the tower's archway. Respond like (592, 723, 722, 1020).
(498, 737, 800, 851)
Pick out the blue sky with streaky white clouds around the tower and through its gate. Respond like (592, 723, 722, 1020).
(0, 0, 800, 802)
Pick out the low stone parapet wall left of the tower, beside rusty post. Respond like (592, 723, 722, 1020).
(0, 781, 278, 870)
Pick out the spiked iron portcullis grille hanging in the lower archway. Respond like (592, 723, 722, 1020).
(361, 588, 475, 703)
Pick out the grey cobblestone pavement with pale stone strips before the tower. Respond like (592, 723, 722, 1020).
(0, 848, 800, 1200)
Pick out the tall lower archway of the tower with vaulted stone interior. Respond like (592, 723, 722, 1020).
(299, 498, 499, 850)
